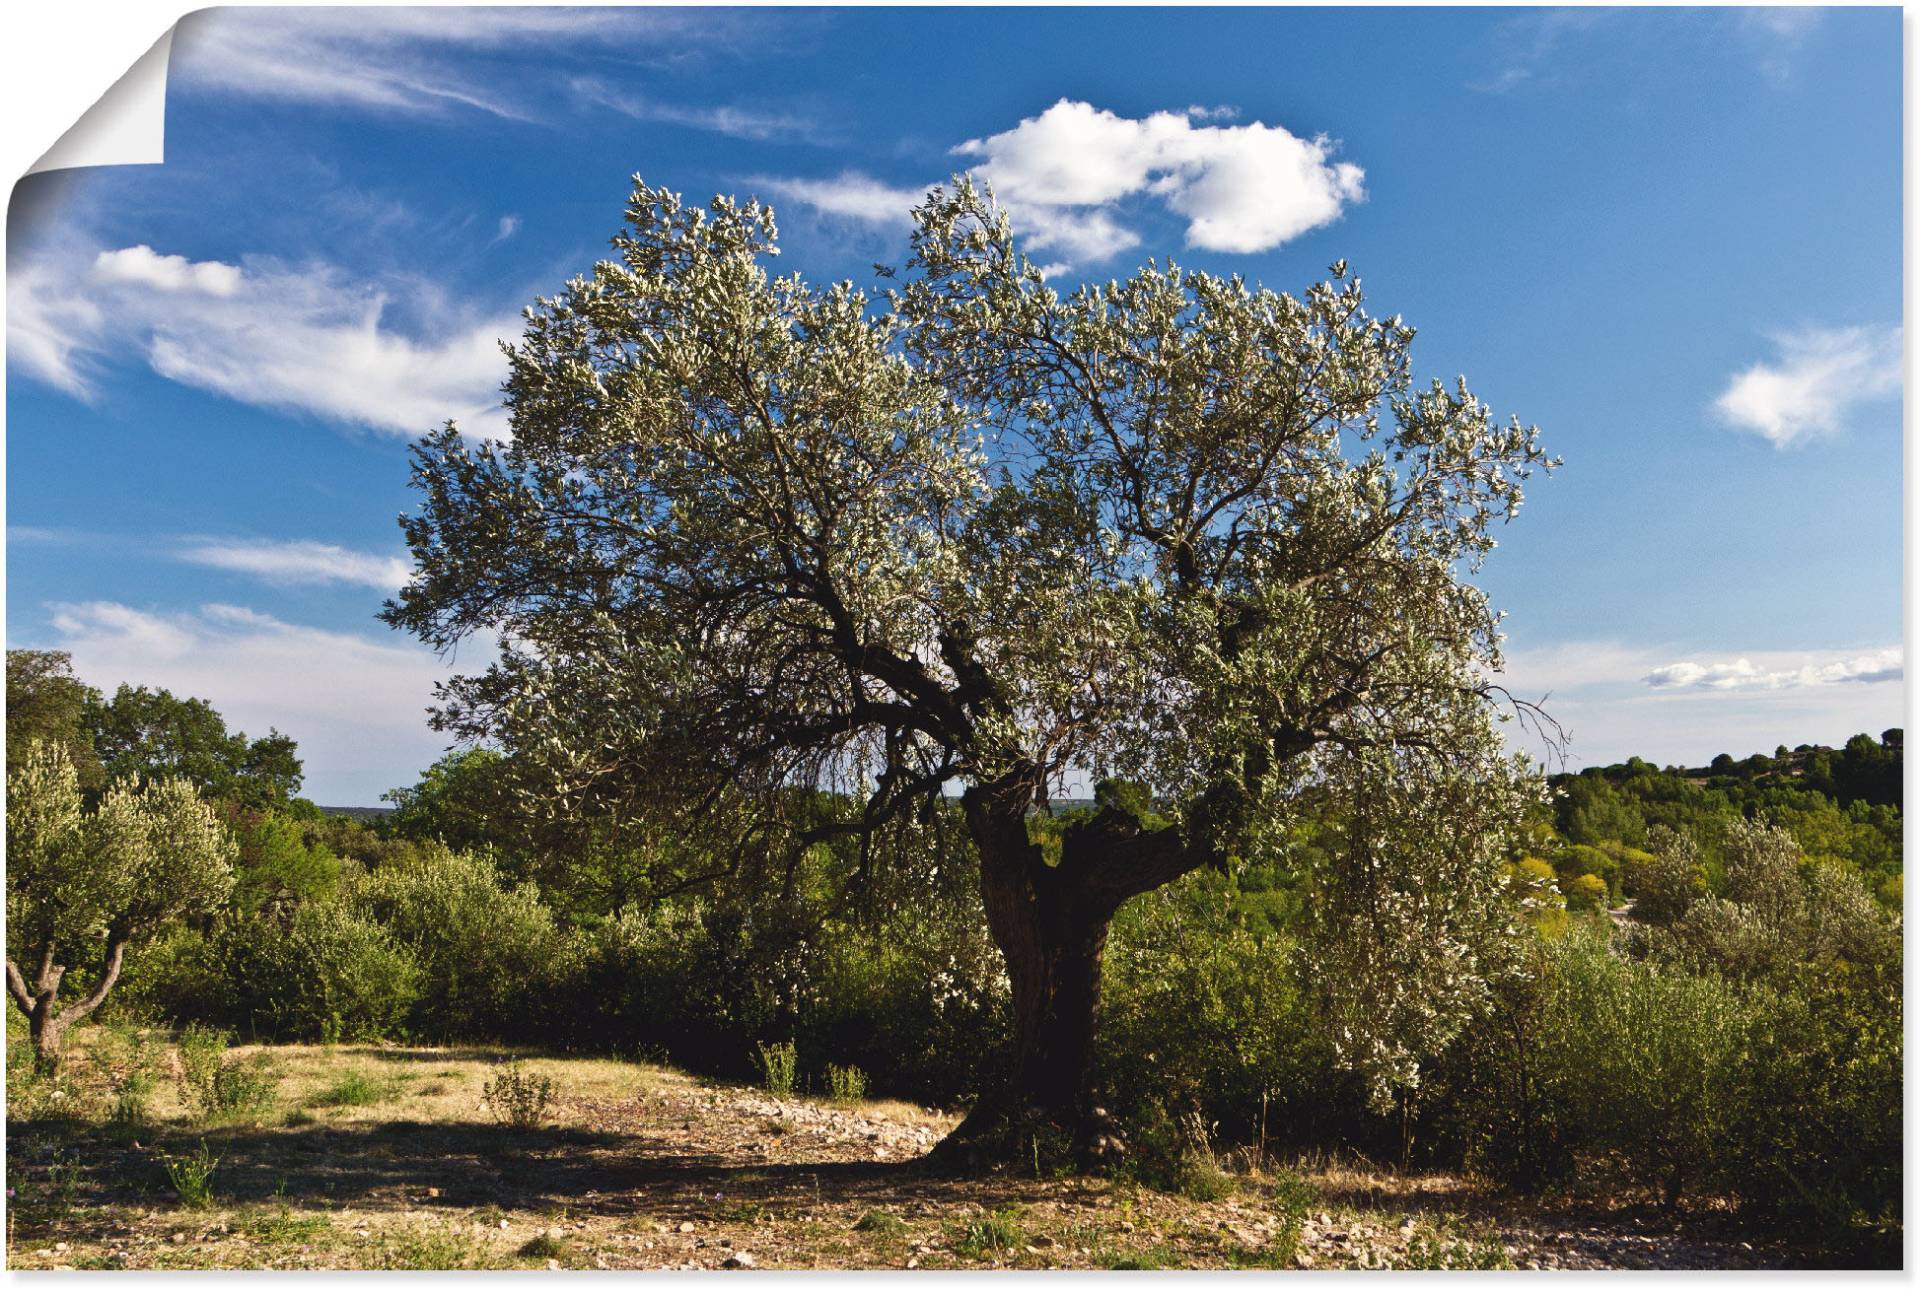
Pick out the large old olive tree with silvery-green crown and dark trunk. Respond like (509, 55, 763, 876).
(386, 181, 1548, 1145)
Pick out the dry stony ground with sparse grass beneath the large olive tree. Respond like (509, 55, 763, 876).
(8, 1047, 1793, 1270)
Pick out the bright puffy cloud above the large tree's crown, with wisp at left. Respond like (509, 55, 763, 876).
(758, 98, 1365, 261)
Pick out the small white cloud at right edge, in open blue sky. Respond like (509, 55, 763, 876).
(1713, 327, 1901, 448)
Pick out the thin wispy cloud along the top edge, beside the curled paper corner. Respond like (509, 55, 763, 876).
(173, 6, 758, 119)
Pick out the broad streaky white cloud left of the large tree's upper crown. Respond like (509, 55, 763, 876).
(8, 244, 520, 436)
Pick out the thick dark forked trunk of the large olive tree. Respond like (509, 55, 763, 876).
(937, 784, 1200, 1166)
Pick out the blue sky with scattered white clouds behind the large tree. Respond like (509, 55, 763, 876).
(6, 10, 1905, 803)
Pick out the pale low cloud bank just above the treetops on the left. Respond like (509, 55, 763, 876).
(52, 601, 472, 805)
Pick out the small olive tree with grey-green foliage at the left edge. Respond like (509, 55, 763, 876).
(6, 742, 236, 1064)
